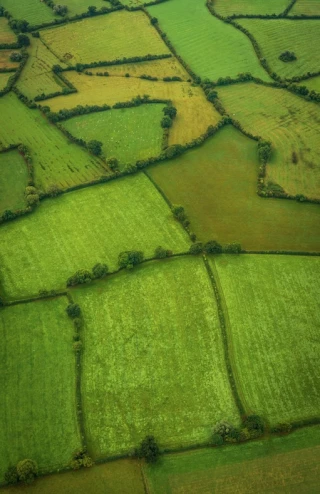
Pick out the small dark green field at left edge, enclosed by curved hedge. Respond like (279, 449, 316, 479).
(0, 151, 28, 215)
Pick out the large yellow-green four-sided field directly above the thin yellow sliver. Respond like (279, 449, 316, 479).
(41, 10, 168, 65)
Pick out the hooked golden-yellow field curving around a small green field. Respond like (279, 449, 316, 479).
(46, 71, 220, 144)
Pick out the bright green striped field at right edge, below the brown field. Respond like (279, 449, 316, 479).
(211, 255, 320, 425)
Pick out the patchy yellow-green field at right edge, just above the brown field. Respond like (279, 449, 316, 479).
(218, 81, 320, 198)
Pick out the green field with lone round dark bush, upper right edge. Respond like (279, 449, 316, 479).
(238, 19, 320, 79)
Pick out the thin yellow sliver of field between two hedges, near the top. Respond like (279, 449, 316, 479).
(89, 57, 190, 81)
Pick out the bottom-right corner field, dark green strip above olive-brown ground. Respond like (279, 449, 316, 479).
(144, 426, 320, 494)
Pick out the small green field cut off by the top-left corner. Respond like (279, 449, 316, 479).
(1, 0, 55, 26)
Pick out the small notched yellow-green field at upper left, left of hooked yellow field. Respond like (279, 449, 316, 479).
(17, 38, 65, 99)
